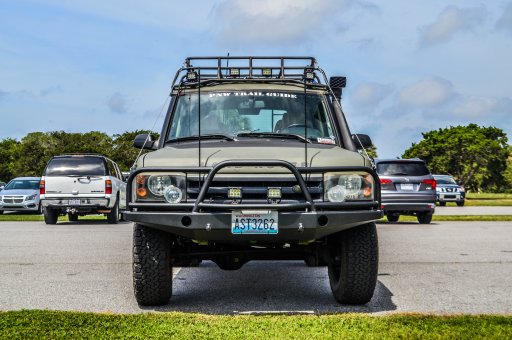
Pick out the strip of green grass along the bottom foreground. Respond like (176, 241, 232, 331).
(0, 310, 512, 339)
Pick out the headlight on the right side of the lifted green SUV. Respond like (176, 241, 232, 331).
(324, 172, 374, 202)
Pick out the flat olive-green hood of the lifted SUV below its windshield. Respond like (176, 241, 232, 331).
(137, 140, 369, 171)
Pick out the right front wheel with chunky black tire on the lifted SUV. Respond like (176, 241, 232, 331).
(328, 222, 379, 305)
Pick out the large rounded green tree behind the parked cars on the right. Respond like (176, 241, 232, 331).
(402, 124, 509, 191)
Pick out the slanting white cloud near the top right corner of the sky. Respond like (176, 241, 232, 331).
(420, 6, 487, 46)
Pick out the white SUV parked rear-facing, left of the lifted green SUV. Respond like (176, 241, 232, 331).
(40, 154, 126, 224)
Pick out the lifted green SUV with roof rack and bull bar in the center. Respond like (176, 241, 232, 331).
(125, 57, 383, 305)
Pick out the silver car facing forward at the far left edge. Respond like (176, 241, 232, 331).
(0, 177, 41, 215)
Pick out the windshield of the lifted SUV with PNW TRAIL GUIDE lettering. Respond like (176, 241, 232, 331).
(167, 91, 334, 144)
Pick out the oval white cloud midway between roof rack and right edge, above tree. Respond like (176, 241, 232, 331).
(398, 77, 456, 108)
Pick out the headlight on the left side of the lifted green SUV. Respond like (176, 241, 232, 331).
(132, 173, 187, 203)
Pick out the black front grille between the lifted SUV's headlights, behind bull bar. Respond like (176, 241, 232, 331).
(187, 177, 323, 203)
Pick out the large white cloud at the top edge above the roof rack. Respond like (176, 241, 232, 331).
(213, 0, 378, 45)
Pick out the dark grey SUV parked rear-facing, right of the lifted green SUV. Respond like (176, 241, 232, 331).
(375, 159, 436, 224)
